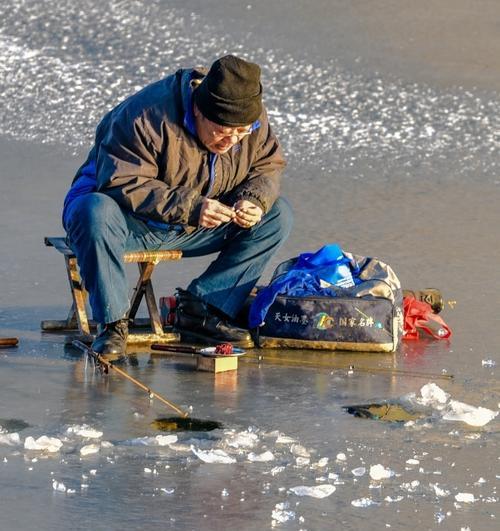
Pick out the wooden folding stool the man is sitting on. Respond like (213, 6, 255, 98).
(41, 236, 182, 344)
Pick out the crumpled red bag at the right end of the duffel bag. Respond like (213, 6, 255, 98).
(403, 297, 451, 339)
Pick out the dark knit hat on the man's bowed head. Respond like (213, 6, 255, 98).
(193, 55, 262, 127)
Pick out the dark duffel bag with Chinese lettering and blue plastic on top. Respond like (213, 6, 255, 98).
(249, 244, 403, 352)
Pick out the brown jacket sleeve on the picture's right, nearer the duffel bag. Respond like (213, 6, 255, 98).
(233, 111, 286, 213)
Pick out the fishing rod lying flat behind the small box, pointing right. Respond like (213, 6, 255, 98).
(151, 343, 454, 380)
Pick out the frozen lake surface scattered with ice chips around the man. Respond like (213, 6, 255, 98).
(0, 0, 500, 530)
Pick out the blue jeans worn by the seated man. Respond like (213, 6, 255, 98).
(66, 192, 293, 324)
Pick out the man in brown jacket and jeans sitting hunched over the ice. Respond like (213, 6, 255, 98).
(63, 55, 292, 354)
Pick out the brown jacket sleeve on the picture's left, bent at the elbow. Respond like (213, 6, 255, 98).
(97, 113, 203, 226)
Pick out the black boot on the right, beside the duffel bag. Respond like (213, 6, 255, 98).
(175, 289, 253, 348)
